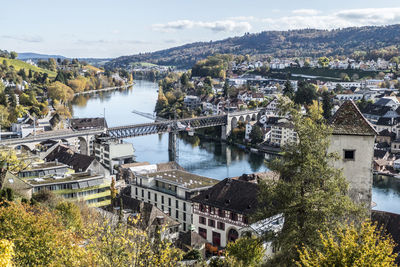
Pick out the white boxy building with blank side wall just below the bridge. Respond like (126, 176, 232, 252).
(93, 140, 135, 174)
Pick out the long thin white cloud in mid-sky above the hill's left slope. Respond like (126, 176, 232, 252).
(152, 20, 251, 32)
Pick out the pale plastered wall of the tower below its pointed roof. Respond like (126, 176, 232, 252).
(328, 135, 375, 207)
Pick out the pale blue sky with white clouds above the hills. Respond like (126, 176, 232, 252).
(0, 0, 400, 58)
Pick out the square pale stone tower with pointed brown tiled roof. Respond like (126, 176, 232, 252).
(329, 101, 377, 208)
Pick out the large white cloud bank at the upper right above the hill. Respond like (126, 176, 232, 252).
(262, 7, 400, 30)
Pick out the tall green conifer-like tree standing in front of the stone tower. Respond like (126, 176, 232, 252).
(255, 98, 365, 265)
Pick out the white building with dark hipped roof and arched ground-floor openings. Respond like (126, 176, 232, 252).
(192, 178, 258, 247)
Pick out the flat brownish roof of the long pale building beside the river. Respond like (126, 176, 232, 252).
(146, 170, 219, 189)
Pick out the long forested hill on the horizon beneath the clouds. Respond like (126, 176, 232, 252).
(106, 24, 400, 68)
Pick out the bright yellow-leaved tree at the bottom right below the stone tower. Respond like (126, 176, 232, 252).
(296, 221, 397, 267)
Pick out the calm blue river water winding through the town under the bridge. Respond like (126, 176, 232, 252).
(73, 80, 400, 214)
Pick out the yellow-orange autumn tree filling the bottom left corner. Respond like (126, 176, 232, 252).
(0, 202, 83, 266)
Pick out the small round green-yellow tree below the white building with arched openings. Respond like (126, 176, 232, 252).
(226, 237, 265, 266)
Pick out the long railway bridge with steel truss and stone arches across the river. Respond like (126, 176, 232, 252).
(0, 109, 265, 160)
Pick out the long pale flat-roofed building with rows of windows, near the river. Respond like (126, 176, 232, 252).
(131, 168, 218, 232)
